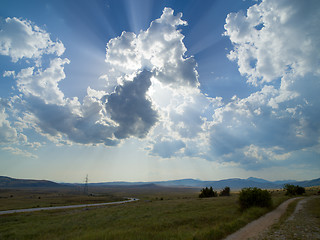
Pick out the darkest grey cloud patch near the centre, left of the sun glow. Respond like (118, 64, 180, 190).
(106, 70, 158, 139)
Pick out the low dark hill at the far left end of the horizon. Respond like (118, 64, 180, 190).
(0, 176, 63, 188)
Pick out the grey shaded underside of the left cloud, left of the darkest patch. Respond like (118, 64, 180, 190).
(25, 97, 118, 146)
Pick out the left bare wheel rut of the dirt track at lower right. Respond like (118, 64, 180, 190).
(225, 198, 299, 240)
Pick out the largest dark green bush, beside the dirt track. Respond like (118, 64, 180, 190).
(239, 187, 272, 210)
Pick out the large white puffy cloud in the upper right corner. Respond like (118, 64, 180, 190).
(225, 0, 320, 84)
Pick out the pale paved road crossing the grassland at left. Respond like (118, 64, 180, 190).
(0, 198, 139, 215)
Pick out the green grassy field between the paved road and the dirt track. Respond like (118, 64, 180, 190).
(0, 187, 318, 240)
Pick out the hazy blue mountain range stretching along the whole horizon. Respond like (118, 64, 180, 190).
(0, 176, 320, 190)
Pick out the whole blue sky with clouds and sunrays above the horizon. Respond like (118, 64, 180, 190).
(0, 0, 320, 182)
